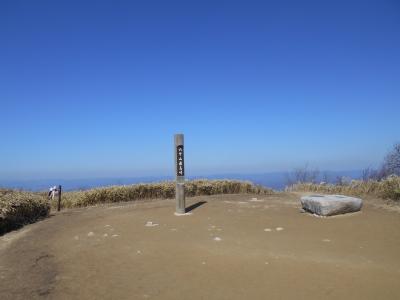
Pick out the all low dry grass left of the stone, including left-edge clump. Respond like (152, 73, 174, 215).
(0, 180, 273, 235)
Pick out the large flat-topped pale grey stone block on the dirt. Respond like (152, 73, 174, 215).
(300, 195, 363, 216)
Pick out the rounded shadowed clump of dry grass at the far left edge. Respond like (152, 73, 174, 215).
(0, 189, 50, 234)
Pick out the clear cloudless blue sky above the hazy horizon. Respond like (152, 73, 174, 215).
(0, 0, 400, 179)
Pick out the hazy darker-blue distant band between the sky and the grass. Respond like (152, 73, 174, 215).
(0, 170, 362, 191)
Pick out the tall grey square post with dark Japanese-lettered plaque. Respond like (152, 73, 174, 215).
(174, 134, 186, 215)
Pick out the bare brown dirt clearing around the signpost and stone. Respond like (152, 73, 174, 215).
(0, 194, 400, 299)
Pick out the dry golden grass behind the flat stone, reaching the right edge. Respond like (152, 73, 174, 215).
(286, 176, 400, 201)
